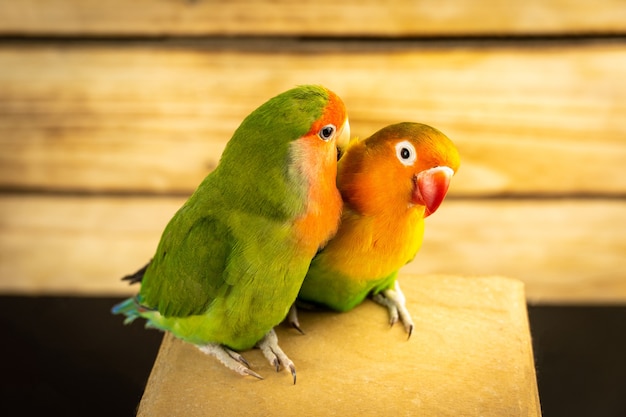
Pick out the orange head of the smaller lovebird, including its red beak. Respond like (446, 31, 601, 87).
(337, 123, 459, 216)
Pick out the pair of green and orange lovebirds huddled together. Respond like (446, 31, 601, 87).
(113, 86, 459, 383)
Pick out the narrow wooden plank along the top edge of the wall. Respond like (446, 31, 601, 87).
(0, 0, 626, 36)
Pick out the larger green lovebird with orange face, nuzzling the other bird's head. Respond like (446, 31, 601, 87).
(112, 85, 350, 384)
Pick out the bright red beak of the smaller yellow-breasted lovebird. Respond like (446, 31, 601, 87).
(411, 166, 454, 217)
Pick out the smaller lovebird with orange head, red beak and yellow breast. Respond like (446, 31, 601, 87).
(288, 122, 459, 337)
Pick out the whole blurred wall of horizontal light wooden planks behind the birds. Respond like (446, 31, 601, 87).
(0, 0, 626, 302)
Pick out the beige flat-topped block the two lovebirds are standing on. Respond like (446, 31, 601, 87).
(138, 275, 541, 417)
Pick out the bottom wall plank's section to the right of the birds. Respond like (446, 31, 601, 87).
(403, 199, 626, 303)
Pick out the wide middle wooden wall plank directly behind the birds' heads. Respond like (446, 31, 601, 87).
(0, 42, 626, 196)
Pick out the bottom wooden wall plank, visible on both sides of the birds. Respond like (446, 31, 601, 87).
(0, 195, 626, 303)
